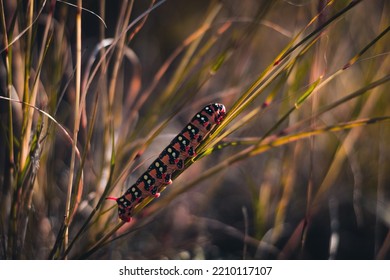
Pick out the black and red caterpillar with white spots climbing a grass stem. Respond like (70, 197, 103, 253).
(107, 103, 226, 222)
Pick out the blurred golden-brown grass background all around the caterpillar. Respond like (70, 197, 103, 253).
(0, 0, 390, 259)
